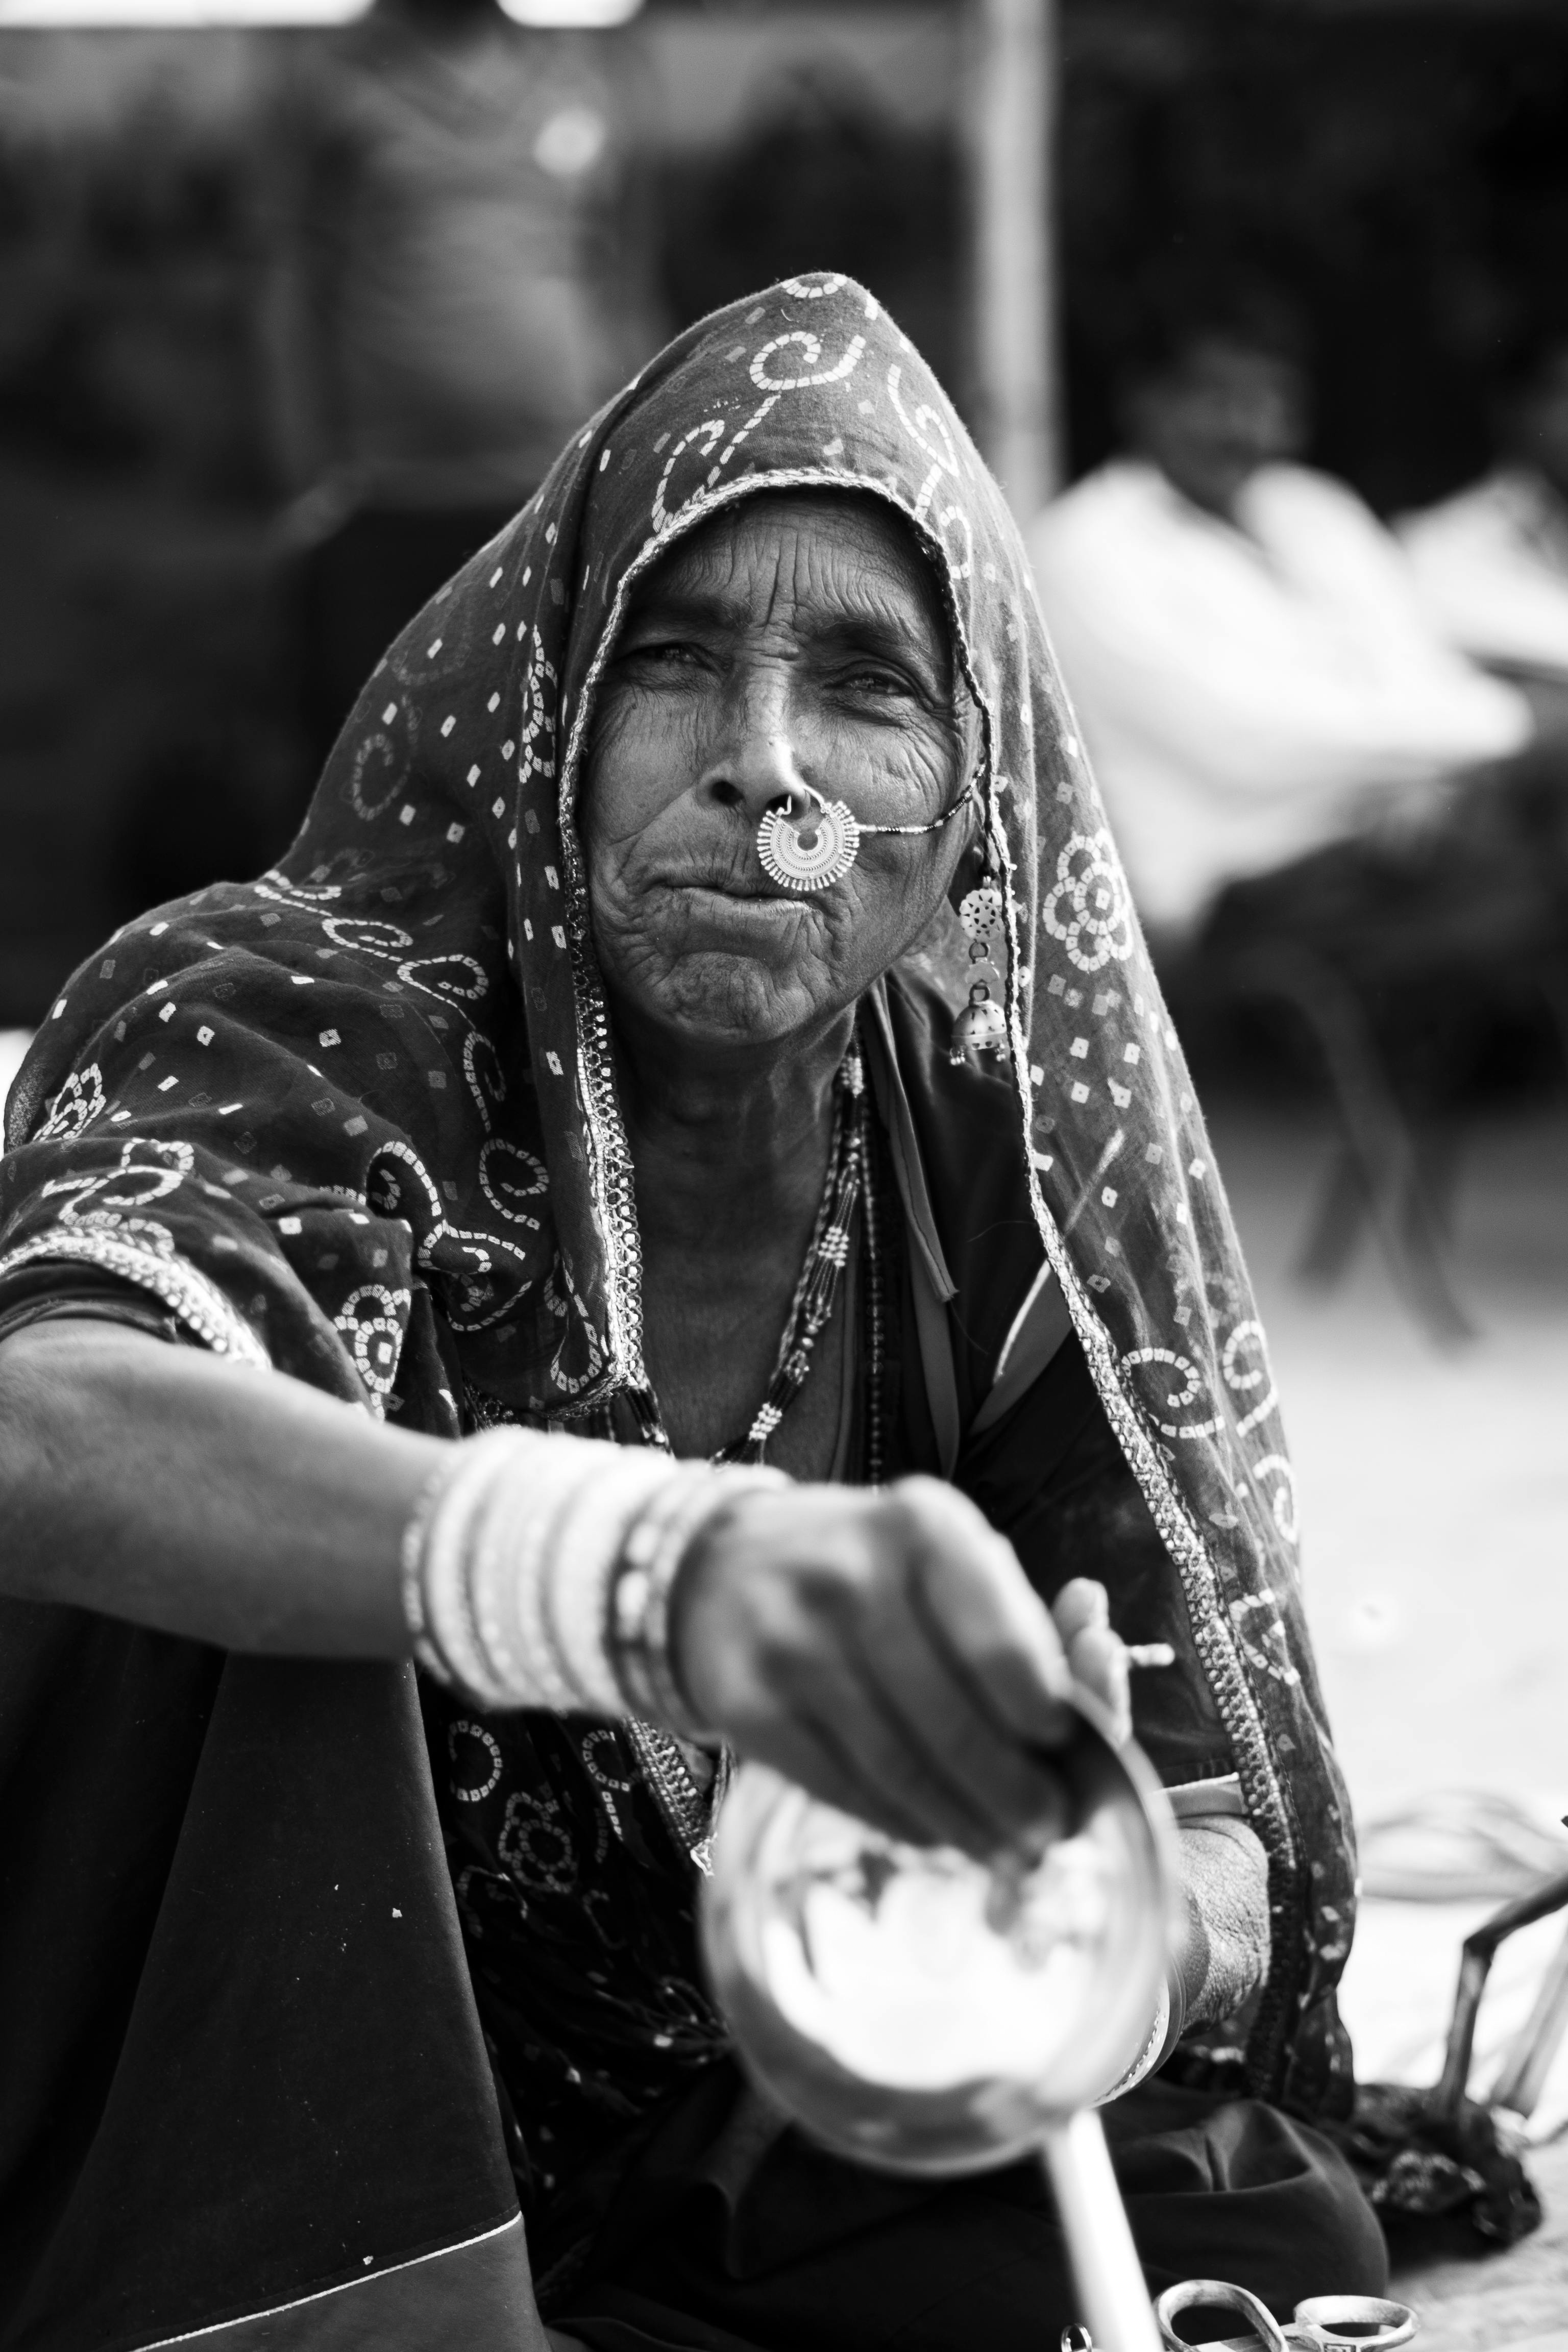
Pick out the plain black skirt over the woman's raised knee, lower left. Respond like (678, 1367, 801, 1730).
(0, 1602, 529, 2352)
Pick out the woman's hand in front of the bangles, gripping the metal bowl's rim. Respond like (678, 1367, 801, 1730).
(672, 1477, 1129, 1856)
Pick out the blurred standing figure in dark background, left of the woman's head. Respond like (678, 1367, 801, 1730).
(271, 0, 663, 783)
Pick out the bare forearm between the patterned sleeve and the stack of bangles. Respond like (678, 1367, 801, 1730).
(0, 1319, 447, 1658)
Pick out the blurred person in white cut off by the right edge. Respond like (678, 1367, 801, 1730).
(1396, 341, 1568, 687)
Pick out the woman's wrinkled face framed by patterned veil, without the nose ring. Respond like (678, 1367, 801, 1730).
(581, 494, 969, 1049)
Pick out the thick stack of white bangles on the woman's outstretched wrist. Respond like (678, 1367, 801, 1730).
(402, 1430, 790, 1741)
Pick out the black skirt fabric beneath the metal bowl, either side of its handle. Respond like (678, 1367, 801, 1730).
(541, 2063, 1387, 2352)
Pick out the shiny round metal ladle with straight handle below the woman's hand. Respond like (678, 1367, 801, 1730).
(703, 1698, 1175, 2352)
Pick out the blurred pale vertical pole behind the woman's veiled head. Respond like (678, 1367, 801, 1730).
(971, 0, 1058, 522)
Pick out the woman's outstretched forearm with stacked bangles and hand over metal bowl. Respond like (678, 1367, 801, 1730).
(0, 1319, 1161, 1853)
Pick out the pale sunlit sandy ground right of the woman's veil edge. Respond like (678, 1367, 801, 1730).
(1213, 1115, 1568, 2352)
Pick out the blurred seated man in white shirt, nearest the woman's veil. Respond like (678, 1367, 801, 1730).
(1030, 320, 1533, 948)
